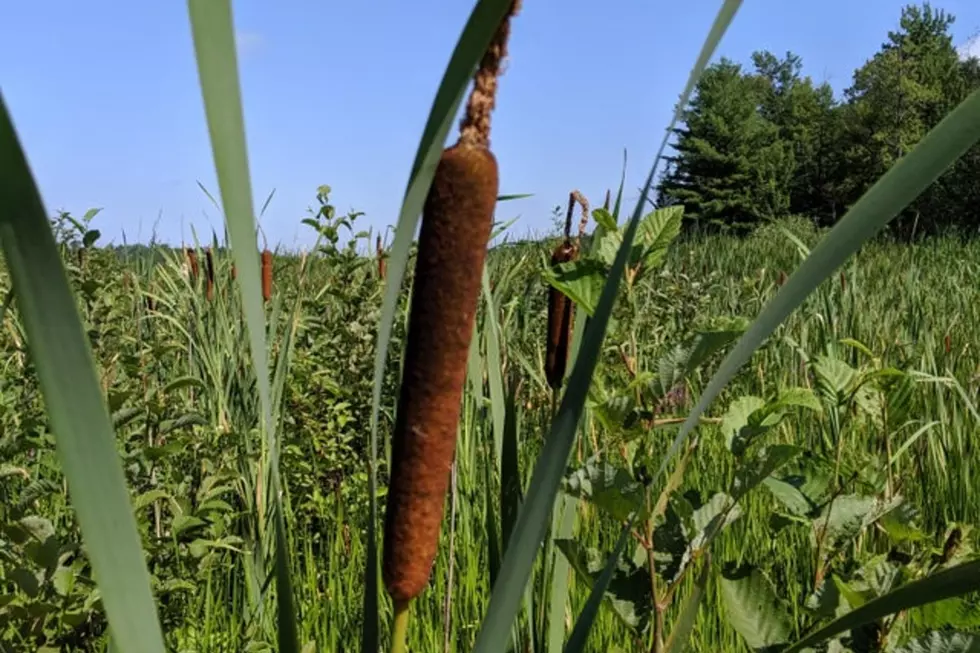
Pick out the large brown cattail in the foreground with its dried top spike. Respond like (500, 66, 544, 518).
(382, 1, 519, 612)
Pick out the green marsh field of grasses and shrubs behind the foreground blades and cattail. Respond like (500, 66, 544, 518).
(0, 208, 980, 652)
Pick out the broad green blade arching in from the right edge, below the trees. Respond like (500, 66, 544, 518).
(654, 85, 980, 482)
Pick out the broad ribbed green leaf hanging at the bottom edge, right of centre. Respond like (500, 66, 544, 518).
(720, 567, 792, 650)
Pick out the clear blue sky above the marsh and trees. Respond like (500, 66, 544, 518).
(0, 0, 980, 249)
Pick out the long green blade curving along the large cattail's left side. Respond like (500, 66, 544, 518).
(361, 0, 511, 653)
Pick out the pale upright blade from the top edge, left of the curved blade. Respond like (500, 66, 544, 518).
(187, 0, 299, 653)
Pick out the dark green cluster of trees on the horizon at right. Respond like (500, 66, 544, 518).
(657, 3, 980, 237)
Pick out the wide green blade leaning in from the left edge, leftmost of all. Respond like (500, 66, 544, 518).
(0, 96, 164, 653)
